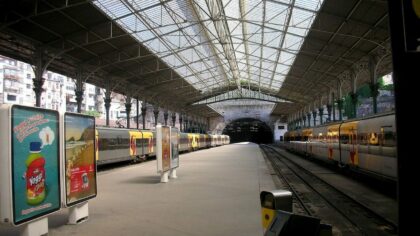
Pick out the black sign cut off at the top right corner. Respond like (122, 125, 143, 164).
(401, 0, 420, 52)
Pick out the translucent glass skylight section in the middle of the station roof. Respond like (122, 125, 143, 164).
(93, 0, 323, 94)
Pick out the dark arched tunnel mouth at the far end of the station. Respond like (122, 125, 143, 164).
(223, 118, 273, 143)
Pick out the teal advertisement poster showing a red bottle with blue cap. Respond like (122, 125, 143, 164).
(11, 105, 60, 225)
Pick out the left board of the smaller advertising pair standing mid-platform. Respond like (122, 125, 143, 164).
(156, 125, 171, 173)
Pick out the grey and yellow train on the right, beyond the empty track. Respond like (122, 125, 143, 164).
(284, 113, 397, 181)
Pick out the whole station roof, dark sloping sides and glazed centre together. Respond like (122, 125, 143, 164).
(0, 0, 392, 117)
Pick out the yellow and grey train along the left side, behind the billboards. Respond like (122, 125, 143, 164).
(96, 127, 230, 165)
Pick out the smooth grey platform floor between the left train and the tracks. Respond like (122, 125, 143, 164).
(0, 143, 275, 236)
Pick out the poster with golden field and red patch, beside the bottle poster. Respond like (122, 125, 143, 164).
(64, 113, 96, 206)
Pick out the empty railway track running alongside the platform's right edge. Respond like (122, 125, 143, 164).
(260, 145, 397, 235)
